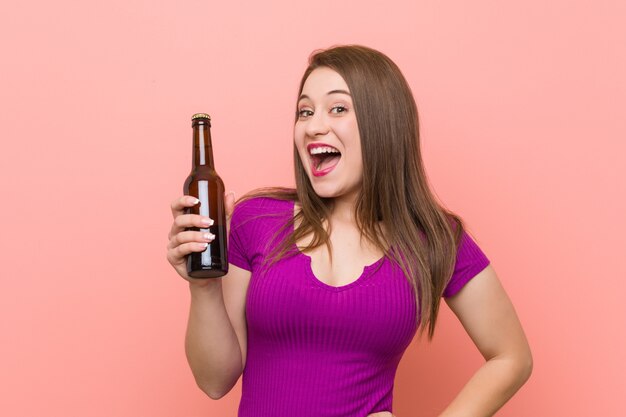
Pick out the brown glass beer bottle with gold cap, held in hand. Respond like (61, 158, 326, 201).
(183, 113, 228, 278)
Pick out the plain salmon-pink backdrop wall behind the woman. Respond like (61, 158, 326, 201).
(0, 0, 626, 417)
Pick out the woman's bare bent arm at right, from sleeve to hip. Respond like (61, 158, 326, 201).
(439, 266, 533, 417)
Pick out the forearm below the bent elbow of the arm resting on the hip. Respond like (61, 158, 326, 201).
(439, 357, 532, 417)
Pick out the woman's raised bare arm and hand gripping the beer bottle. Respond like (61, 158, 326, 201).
(167, 195, 250, 399)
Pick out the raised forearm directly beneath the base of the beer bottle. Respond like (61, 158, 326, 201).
(185, 281, 242, 399)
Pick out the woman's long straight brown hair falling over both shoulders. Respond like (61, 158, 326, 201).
(241, 45, 464, 338)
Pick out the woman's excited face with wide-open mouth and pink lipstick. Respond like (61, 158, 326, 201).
(294, 67, 363, 202)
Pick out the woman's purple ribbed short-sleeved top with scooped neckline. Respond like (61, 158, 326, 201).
(229, 198, 489, 417)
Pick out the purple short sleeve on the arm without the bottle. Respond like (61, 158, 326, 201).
(443, 230, 489, 297)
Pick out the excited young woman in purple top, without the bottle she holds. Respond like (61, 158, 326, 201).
(168, 46, 532, 417)
